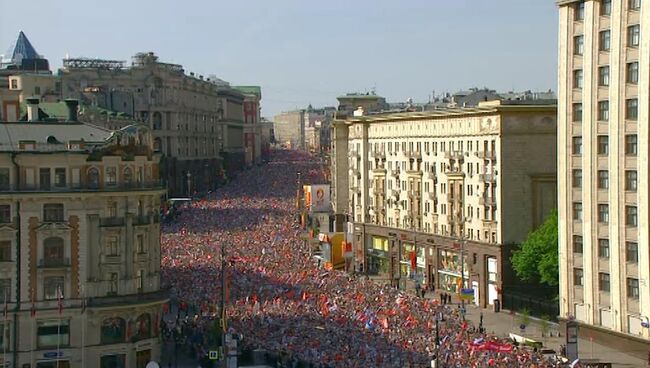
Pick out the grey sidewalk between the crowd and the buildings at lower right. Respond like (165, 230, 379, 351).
(450, 293, 647, 368)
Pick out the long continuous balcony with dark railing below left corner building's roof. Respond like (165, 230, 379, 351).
(0, 180, 165, 194)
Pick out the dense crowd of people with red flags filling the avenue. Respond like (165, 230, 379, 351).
(161, 150, 555, 368)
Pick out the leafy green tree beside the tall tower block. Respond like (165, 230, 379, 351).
(511, 210, 559, 286)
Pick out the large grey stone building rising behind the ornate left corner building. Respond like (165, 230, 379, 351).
(59, 53, 245, 195)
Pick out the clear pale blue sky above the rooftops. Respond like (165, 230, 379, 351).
(0, 0, 557, 117)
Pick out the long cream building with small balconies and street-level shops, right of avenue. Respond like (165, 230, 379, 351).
(331, 101, 557, 306)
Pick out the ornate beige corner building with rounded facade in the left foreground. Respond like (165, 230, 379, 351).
(0, 99, 167, 368)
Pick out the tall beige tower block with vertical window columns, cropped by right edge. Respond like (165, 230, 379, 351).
(558, 0, 650, 348)
